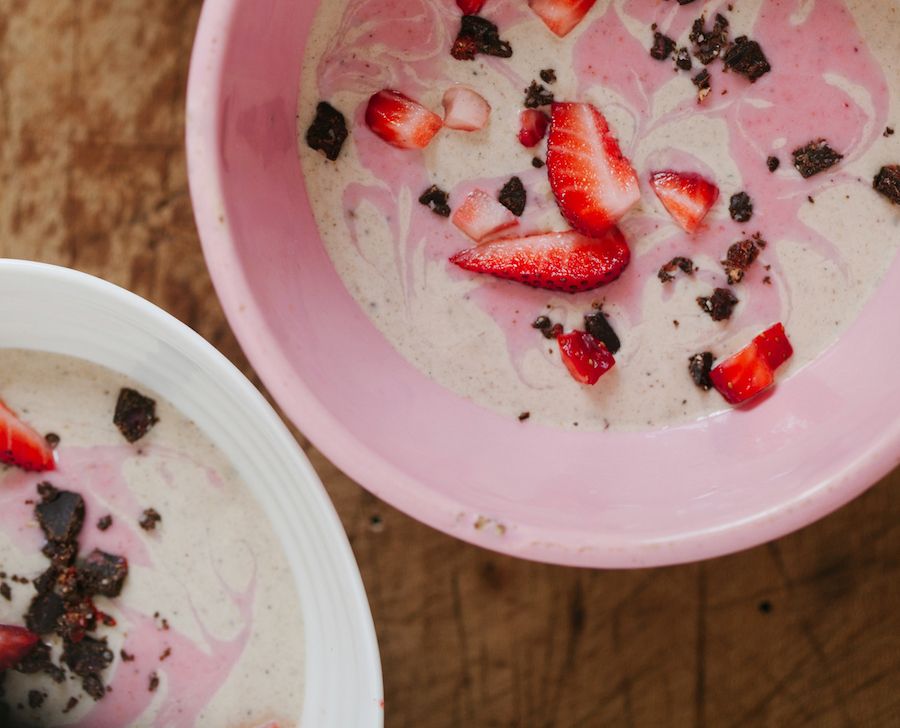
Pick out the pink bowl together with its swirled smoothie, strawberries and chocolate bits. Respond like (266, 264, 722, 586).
(188, 0, 900, 567)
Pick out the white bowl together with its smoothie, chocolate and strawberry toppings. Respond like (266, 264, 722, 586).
(0, 260, 383, 728)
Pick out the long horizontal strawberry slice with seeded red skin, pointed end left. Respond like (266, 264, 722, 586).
(450, 228, 631, 293)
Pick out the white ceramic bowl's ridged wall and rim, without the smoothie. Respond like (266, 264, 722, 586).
(0, 260, 383, 728)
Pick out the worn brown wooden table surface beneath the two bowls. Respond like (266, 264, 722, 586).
(0, 0, 900, 728)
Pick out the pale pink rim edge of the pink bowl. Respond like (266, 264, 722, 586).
(186, 0, 900, 569)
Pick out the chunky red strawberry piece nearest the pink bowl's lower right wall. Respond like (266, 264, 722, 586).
(710, 324, 794, 405)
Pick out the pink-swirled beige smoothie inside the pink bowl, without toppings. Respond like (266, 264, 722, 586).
(298, 0, 900, 429)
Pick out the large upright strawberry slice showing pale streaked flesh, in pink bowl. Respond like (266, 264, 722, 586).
(547, 103, 641, 236)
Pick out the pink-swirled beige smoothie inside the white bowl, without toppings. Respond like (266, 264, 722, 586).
(0, 350, 304, 728)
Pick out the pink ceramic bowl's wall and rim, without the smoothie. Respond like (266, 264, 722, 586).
(187, 0, 900, 567)
